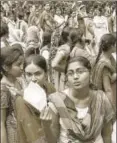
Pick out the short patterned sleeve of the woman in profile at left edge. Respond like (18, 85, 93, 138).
(1, 90, 9, 109)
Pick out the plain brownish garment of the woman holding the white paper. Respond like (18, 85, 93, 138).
(16, 83, 55, 143)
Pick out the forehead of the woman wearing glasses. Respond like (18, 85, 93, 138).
(67, 61, 85, 70)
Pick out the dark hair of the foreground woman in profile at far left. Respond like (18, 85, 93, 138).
(0, 44, 24, 75)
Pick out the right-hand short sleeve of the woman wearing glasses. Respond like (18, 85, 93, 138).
(102, 94, 115, 123)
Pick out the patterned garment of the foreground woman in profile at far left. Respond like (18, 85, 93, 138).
(0, 81, 22, 143)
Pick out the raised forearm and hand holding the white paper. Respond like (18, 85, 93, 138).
(40, 103, 60, 143)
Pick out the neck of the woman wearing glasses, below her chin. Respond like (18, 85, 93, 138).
(71, 86, 89, 100)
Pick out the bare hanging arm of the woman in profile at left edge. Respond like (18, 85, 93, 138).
(1, 109, 7, 143)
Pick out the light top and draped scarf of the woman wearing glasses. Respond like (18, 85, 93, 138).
(49, 90, 115, 143)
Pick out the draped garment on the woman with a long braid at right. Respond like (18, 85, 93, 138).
(91, 56, 116, 104)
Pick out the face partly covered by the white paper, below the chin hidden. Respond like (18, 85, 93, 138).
(25, 62, 46, 86)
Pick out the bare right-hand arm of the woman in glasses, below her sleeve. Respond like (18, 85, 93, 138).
(102, 121, 112, 143)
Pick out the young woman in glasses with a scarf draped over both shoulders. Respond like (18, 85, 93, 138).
(41, 57, 115, 143)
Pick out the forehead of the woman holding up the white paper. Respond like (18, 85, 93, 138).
(25, 62, 43, 73)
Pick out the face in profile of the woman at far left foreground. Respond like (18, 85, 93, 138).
(8, 56, 24, 78)
